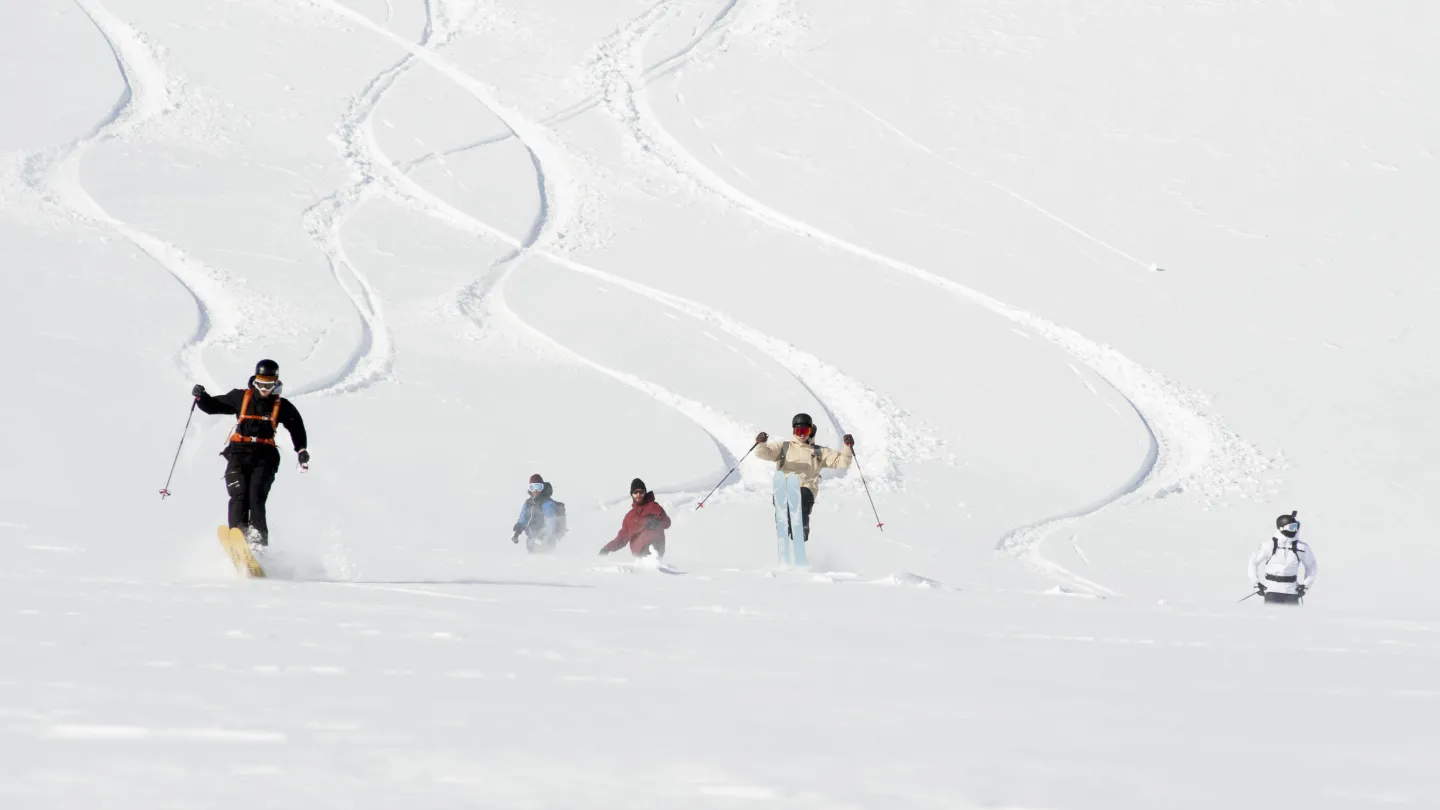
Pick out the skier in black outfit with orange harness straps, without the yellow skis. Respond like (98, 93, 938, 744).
(190, 360, 310, 546)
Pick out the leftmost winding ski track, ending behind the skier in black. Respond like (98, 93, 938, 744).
(22, 0, 245, 380)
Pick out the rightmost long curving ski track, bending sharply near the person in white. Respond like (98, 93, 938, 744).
(592, 3, 1270, 592)
